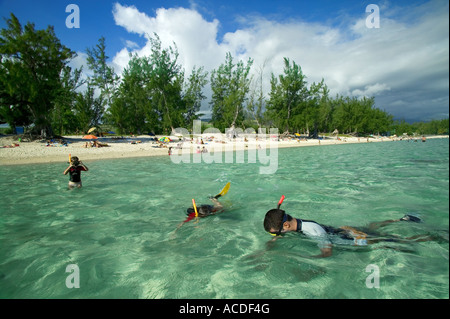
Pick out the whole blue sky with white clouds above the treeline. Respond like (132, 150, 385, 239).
(0, 0, 449, 122)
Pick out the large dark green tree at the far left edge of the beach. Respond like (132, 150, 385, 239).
(0, 13, 75, 135)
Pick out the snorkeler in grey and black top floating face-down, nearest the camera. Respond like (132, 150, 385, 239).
(264, 208, 433, 257)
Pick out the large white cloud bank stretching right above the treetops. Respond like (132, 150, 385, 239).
(113, 1, 449, 120)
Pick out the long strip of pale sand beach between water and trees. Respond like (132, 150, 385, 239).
(0, 134, 448, 166)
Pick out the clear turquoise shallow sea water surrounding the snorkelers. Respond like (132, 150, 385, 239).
(0, 139, 449, 299)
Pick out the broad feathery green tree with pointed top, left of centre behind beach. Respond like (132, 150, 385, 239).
(107, 34, 193, 134)
